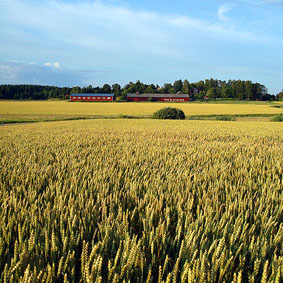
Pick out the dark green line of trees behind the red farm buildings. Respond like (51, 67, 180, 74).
(0, 79, 279, 100)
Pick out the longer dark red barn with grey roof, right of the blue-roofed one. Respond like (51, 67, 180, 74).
(127, 93, 190, 102)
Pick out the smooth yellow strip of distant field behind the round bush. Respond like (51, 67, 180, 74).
(0, 101, 283, 120)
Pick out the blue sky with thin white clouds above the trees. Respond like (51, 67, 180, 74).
(0, 0, 283, 94)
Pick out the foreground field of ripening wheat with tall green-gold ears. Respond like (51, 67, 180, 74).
(0, 119, 283, 283)
